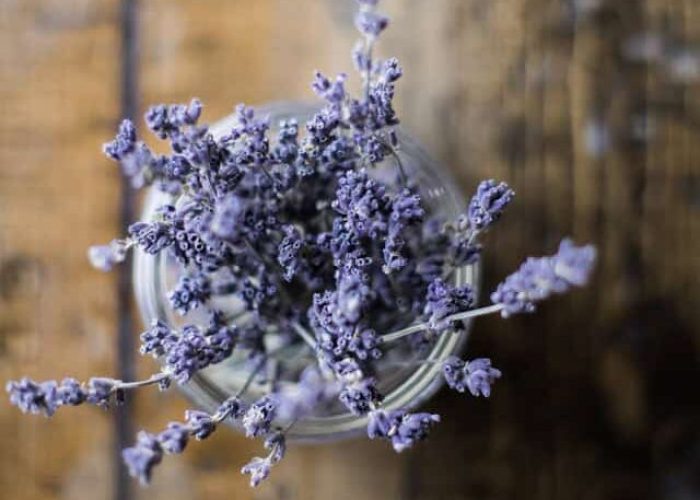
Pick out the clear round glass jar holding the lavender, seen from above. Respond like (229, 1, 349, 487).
(133, 103, 478, 442)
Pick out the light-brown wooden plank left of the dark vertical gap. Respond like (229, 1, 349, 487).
(0, 0, 119, 499)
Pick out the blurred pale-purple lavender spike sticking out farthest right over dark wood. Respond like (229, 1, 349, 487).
(491, 239, 596, 318)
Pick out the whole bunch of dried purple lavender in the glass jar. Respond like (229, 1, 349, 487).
(7, 0, 595, 486)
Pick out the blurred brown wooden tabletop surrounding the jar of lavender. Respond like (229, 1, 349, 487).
(0, 0, 700, 500)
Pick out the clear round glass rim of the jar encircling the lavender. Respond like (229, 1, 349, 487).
(133, 102, 479, 442)
